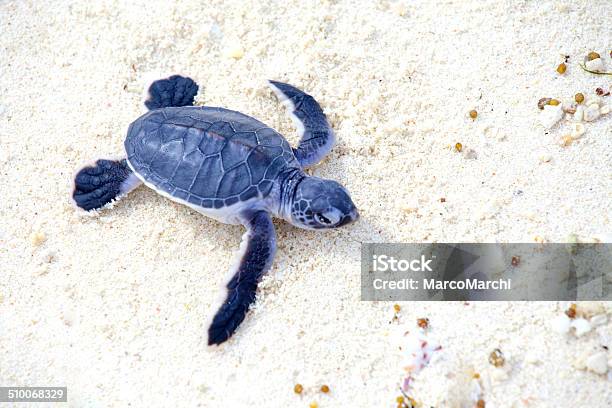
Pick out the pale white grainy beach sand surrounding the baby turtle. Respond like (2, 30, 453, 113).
(0, 0, 612, 407)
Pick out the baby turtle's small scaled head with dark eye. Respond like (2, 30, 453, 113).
(291, 177, 359, 229)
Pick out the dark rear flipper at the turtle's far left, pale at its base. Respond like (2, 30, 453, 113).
(72, 159, 141, 211)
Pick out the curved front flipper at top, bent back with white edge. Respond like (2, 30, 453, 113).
(268, 81, 336, 167)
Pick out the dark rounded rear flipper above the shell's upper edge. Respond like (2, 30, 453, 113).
(144, 75, 199, 110)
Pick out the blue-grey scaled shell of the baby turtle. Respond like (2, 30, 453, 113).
(125, 106, 300, 208)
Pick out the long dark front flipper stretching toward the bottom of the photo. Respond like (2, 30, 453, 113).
(208, 211, 276, 345)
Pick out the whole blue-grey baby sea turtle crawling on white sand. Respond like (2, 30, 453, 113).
(73, 75, 358, 345)
